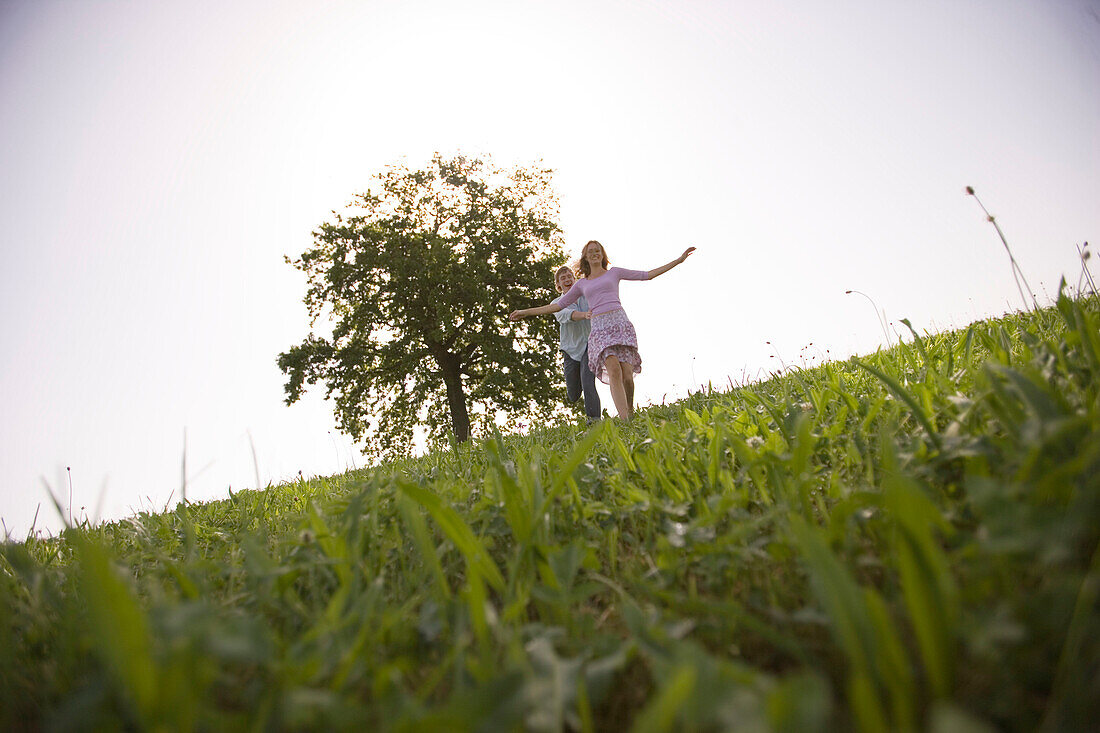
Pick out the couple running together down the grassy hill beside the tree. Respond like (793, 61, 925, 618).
(508, 240, 695, 423)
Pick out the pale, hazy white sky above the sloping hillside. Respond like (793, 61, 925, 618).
(0, 0, 1100, 537)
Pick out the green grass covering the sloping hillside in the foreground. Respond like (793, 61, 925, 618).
(0, 288, 1100, 731)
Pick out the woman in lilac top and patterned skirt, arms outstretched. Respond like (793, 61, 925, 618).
(508, 240, 695, 420)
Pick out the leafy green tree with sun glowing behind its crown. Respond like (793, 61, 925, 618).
(278, 154, 564, 457)
